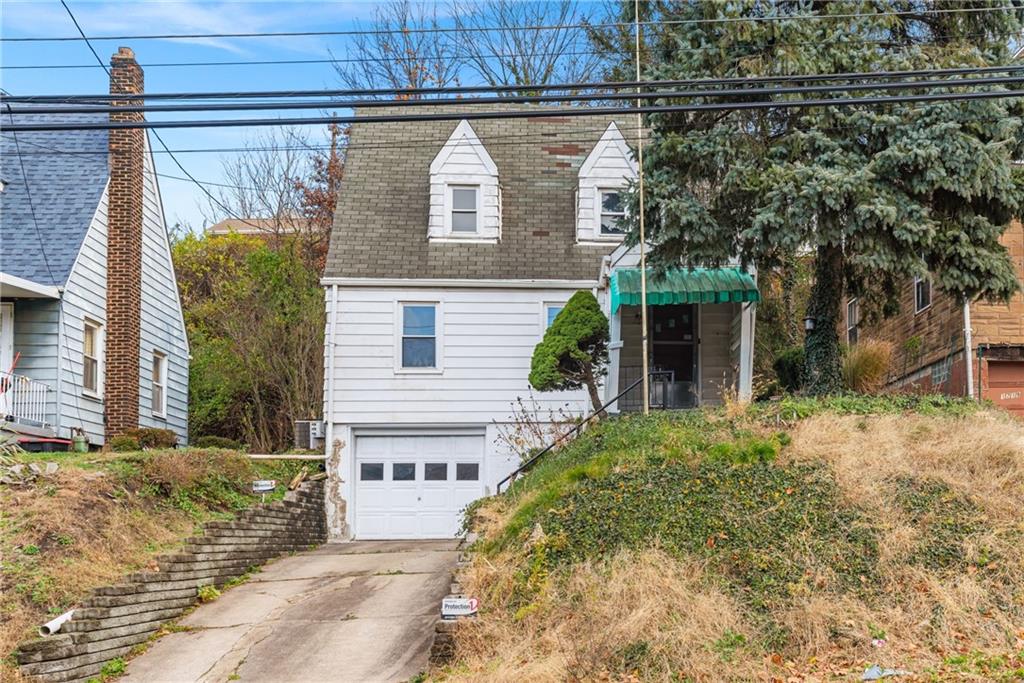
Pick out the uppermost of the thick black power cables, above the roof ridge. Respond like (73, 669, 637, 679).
(0, 65, 1024, 104)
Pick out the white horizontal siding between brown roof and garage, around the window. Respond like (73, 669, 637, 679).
(329, 288, 589, 424)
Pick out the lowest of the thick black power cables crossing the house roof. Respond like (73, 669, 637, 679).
(6, 87, 1024, 132)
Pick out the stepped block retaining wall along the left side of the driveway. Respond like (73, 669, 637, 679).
(17, 481, 327, 683)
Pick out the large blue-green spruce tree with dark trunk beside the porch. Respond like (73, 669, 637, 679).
(593, 0, 1024, 394)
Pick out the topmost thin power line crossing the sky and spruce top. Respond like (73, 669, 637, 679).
(0, 5, 1018, 43)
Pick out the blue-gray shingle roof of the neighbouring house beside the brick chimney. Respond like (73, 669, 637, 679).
(0, 104, 109, 287)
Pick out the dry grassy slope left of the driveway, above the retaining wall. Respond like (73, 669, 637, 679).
(0, 449, 303, 680)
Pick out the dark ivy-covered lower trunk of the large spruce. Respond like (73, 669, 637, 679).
(804, 245, 843, 396)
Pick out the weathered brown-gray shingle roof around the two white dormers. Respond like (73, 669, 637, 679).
(324, 104, 636, 280)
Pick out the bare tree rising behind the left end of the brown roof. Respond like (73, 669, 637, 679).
(334, 0, 459, 97)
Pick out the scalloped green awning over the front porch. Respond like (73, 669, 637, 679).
(611, 268, 761, 313)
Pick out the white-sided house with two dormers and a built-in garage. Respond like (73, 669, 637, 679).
(323, 105, 752, 541)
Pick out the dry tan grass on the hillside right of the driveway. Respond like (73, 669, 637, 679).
(432, 412, 1024, 681)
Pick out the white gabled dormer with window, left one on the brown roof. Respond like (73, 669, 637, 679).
(427, 121, 502, 243)
